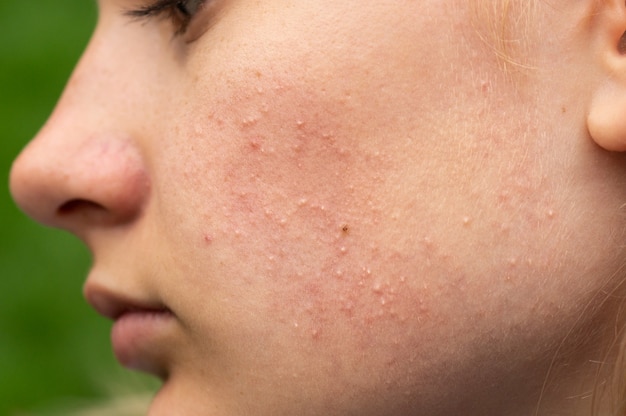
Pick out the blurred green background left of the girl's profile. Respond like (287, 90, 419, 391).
(0, 0, 153, 415)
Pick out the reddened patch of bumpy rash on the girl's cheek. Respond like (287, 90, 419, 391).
(185, 70, 428, 339)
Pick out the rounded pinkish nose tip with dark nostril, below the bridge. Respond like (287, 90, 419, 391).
(10, 133, 149, 236)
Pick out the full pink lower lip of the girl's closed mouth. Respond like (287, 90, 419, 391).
(111, 310, 173, 376)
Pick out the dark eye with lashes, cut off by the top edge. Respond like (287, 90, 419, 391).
(126, 0, 207, 36)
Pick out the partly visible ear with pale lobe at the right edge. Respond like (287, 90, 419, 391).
(587, 0, 626, 152)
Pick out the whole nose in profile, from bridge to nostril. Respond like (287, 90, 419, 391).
(10, 30, 149, 239)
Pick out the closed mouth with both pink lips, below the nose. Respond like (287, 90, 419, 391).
(87, 290, 176, 379)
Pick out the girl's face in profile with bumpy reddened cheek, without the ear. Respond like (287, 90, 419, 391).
(11, 0, 626, 416)
